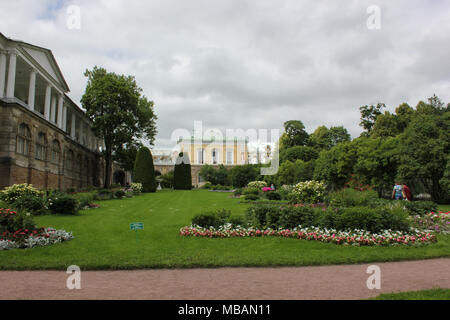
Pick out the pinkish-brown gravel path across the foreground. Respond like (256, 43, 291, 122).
(0, 259, 450, 300)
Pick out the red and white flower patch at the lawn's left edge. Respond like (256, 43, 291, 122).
(0, 228, 73, 251)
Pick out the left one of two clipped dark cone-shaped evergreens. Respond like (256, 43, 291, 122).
(133, 147, 157, 192)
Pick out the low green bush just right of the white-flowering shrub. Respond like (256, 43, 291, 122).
(326, 188, 383, 208)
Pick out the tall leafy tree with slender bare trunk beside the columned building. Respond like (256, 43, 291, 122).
(81, 67, 157, 188)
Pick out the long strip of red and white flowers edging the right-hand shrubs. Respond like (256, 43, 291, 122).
(180, 224, 437, 246)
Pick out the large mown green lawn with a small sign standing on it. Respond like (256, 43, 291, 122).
(0, 190, 450, 270)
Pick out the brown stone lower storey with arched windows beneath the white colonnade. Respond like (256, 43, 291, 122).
(0, 101, 104, 190)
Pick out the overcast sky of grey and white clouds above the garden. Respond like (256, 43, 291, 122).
(0, 0, 450, 146)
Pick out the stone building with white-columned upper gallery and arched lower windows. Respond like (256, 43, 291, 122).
(0, 33, 108, 190)
